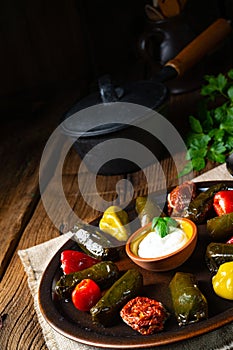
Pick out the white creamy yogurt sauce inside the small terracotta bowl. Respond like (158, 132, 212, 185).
(138, 226, 188, 258)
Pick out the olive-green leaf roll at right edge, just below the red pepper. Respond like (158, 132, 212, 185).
(207, 213, 233, 242)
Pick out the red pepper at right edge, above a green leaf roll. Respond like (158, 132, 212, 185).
(213, 190, 233, 216)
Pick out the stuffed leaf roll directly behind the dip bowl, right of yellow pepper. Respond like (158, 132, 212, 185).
(135, 196, 165, 227)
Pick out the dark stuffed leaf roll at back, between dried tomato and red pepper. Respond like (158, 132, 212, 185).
(184, 183, 227, 224)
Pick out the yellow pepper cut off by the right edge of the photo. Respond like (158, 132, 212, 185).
(212, 261, 233, 300)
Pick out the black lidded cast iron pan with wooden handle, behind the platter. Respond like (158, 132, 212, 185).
(61, 18, 231, 175)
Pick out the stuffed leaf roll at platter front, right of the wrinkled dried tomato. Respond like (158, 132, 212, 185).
(169, 272, 208, 326)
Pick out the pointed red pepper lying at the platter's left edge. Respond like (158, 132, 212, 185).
(61, 250, 99, 275)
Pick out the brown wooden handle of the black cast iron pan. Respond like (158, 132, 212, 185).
(165, 18, 232, 76)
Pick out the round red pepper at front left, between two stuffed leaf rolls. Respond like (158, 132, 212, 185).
(72, 278, 101, 311)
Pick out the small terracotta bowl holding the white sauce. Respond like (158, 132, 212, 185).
(125, 218, 197, 271)
